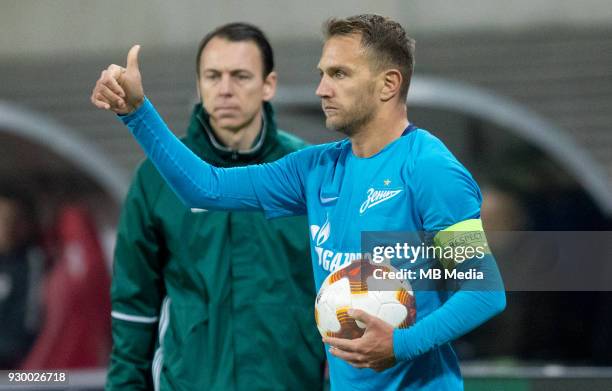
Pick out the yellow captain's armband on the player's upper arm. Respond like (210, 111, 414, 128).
(433, 219, 491, 269)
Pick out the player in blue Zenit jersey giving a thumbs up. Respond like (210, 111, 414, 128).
(93, 15, 505, 390)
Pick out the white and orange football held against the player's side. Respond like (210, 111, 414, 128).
(315, 260, 416, 339)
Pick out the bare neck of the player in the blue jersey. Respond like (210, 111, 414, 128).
(351, 102, 408, 157)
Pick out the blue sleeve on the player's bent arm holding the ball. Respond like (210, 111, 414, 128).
(393, 143, 506, 360)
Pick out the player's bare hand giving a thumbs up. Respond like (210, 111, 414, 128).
(91, 45, 144, 114)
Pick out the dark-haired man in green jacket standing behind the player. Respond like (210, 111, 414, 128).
(106, 23, 324, 391)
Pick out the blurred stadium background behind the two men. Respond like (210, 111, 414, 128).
(0, 0, 612, 390)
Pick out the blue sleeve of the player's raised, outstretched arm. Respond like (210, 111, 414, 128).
(120, 97, 305, 217)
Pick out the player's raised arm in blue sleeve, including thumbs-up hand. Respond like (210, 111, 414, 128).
(91, 45, 305, 216)
